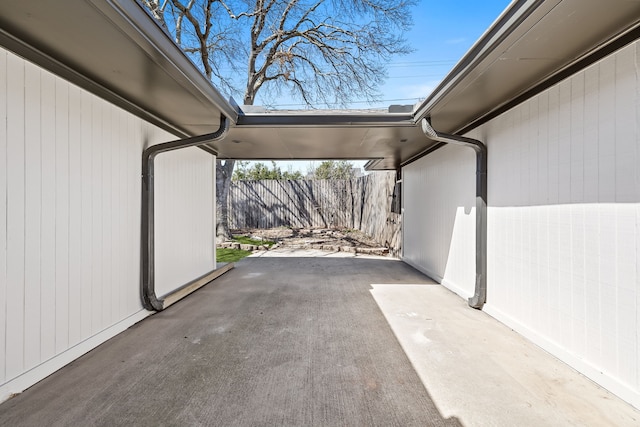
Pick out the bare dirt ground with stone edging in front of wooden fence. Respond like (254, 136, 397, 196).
(232, 227, 388, 255)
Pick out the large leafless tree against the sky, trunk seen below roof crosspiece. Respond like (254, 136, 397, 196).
(139, 0, 416, 239)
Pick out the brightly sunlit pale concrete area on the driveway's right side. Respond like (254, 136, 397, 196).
(371, 284, 640, 426)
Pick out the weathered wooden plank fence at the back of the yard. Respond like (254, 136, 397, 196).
(228, 172, 401, 255)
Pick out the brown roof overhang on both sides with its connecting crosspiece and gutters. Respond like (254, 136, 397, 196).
(0, 0, 640, 169)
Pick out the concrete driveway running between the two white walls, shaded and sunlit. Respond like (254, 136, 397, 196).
(0, 252, 640, 426)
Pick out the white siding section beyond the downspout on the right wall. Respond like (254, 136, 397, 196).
(402, 145, 475, 297)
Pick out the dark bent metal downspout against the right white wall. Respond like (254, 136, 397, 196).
(422, 118, 487, 309)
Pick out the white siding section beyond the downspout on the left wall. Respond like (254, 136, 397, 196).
(155, 147, 216, 296)
